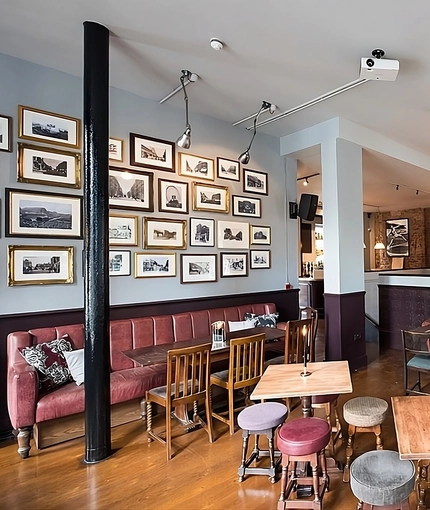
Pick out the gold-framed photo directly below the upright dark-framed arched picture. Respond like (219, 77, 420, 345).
(143, 217, 187, 250)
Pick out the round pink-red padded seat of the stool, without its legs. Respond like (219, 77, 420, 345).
(278, 418, 331, 456)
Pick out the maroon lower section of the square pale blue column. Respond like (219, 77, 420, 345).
(324, 292, 367, 370)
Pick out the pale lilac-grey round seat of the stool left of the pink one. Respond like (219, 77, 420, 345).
(237, 402, 288, 430)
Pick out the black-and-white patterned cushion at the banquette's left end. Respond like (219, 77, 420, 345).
(19, 335, 72, 391)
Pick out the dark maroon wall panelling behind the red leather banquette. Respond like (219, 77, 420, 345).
(0, 289, 299, 437)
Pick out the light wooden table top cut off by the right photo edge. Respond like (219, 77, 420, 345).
(391, 395, 430, 460)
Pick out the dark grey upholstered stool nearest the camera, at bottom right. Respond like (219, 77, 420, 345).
(351, 450, 415, 510)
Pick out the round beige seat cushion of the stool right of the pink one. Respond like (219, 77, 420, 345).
(343, 397, 388, 427)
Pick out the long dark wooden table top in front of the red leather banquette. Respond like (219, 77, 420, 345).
(123, 328, 285, 367)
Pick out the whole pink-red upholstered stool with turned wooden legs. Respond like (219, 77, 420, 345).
(277, 418, 331, 510)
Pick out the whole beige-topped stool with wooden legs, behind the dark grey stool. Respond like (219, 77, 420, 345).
(343, 397, 388, 482)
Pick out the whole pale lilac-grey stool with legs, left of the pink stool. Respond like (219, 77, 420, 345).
(237, 402, 288, 483)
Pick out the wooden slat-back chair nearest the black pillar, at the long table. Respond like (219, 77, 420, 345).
(146, 343, 213, 460)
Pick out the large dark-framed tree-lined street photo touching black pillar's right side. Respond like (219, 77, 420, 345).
(109, 167, 154, 212)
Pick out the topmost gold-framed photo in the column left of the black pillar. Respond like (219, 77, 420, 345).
(18, 105, 81, 149)
